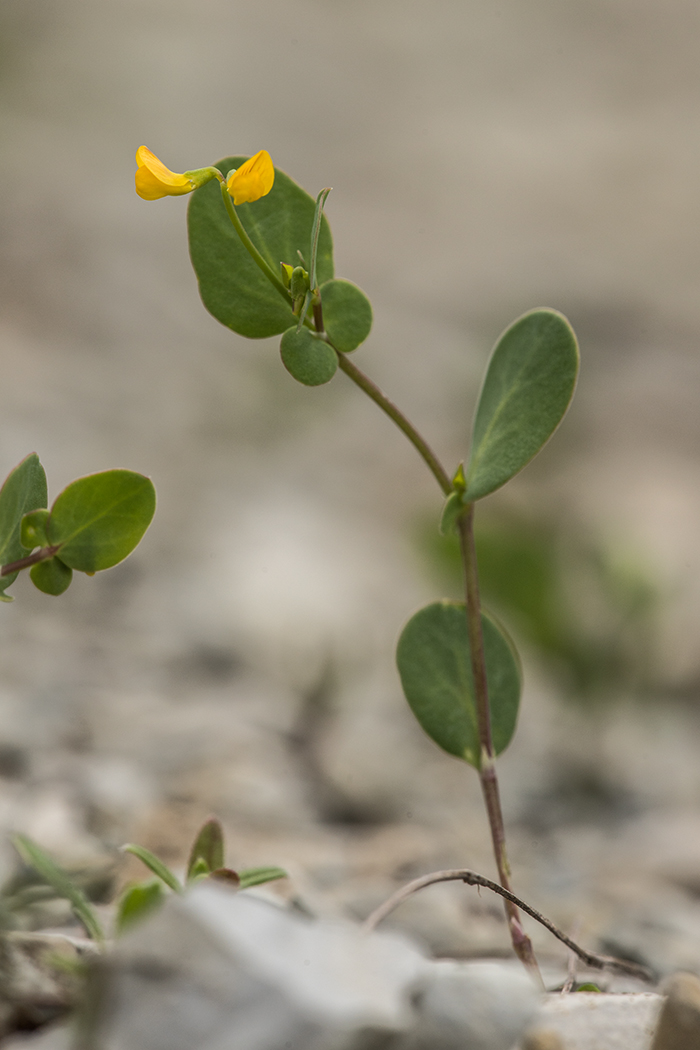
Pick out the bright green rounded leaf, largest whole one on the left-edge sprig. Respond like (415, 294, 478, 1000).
(46, 470, 155, 572)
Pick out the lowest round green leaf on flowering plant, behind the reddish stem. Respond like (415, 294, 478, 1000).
(397, 602, 522, 769)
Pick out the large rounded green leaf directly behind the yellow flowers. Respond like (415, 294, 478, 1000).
(188, 156, 333, 339)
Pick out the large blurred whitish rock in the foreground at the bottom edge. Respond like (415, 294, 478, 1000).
(96, 885, 537, 1050)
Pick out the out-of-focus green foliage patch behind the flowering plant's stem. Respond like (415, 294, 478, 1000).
(416, 510, 659, 704)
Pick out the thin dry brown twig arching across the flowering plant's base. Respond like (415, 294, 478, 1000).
(362, 867, 654, 982)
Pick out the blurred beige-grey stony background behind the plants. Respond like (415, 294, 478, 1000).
(0, 0, 700, 972)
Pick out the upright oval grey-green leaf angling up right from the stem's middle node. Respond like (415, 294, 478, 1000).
(466, 310, 579, 502)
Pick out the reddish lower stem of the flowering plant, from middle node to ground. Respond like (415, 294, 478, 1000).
(458, 503, 542, 980)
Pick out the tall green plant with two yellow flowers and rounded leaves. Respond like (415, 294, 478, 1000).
(136, 141, 579, 970)
